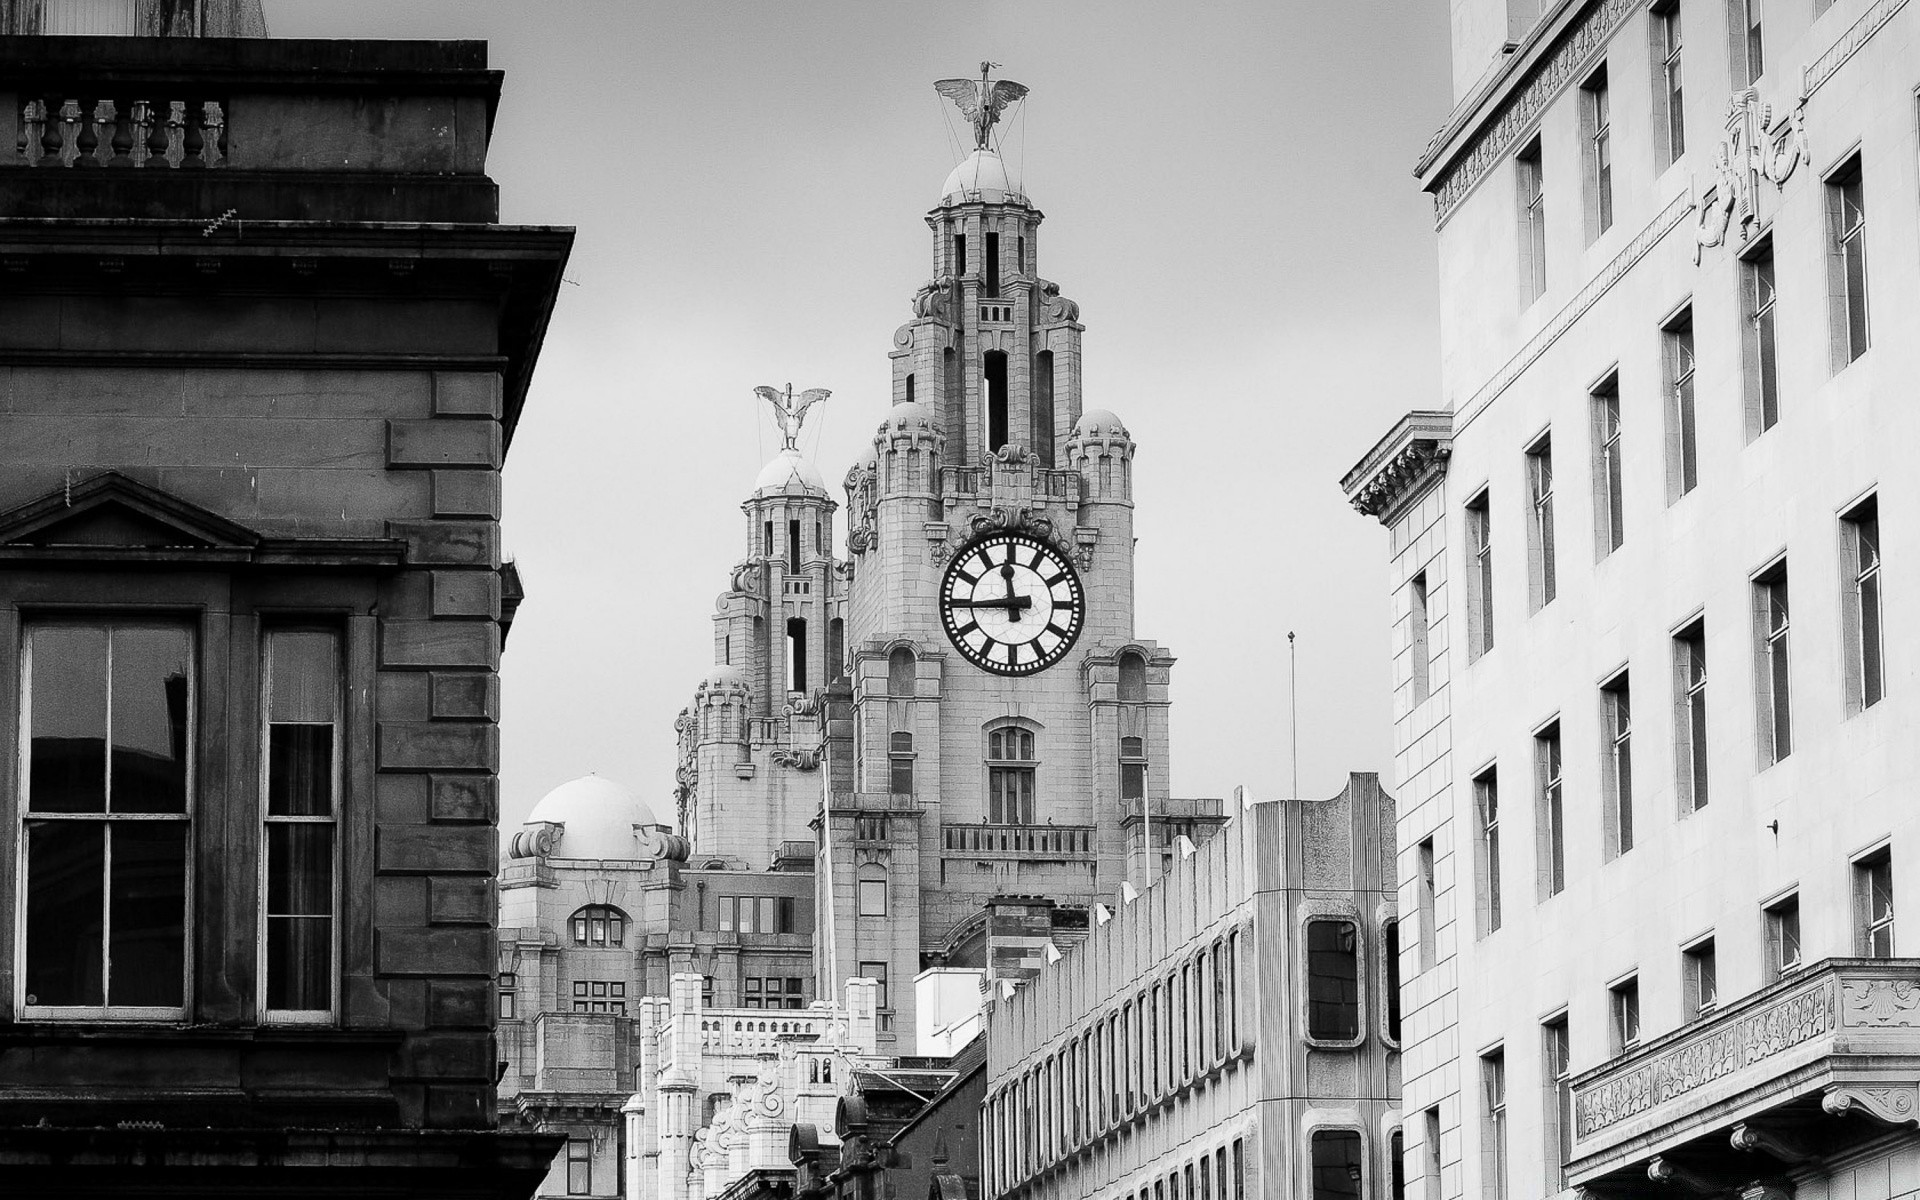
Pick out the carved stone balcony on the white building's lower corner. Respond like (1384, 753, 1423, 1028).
(1567, 958, 1920, 1194)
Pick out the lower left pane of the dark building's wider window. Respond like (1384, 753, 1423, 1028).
(27, 822, 106, 1004)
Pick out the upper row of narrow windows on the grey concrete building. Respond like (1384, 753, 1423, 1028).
(985, 929, 1242, 1194)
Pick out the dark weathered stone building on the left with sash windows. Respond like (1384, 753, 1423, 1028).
(0, 14, 572, 1196)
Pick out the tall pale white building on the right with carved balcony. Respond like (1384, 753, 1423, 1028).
(1344, 0, 1920, 1200)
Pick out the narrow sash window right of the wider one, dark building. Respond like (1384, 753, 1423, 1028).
(261, 630, 342, 1020)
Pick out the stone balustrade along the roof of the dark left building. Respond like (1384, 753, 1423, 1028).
(13, 88, 227, 169)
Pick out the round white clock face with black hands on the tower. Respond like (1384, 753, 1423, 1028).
(941, 534, 1085, 676)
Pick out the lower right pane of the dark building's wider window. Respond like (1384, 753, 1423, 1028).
(108, 822, 186, 1008)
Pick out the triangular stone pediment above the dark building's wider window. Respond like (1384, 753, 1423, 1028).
(0, 470, 259, 551)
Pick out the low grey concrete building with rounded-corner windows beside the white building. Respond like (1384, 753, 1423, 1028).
(981, 774, 1404, 1200)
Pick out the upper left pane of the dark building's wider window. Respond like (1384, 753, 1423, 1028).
(29, 628, 108, 814)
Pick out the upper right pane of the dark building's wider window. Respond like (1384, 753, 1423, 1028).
(111, 630, 190, 812)
